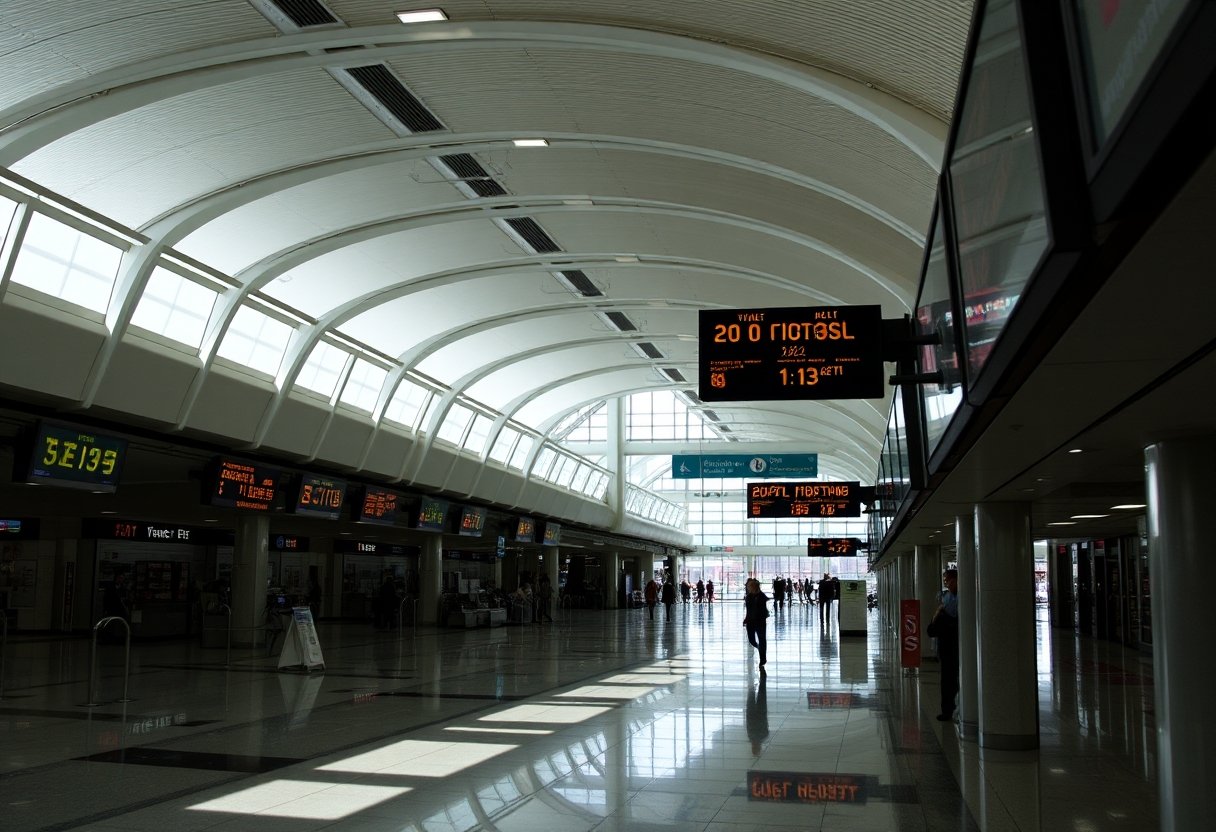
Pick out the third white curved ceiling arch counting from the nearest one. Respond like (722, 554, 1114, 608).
(233, 195, 912, 305)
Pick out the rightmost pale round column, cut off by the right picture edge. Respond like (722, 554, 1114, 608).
(1144, 437, 1216, 830)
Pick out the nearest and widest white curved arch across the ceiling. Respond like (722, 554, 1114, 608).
(0, 21, 947, 172)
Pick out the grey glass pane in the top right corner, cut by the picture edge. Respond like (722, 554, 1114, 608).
(1073, 0, 1195, 147)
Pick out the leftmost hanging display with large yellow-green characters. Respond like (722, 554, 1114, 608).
(27, 422, 126, 491)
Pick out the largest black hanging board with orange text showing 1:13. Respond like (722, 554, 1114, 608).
(698, 305, 885, 401)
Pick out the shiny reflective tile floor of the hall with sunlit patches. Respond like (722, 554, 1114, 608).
(0, 602, 1158, 832)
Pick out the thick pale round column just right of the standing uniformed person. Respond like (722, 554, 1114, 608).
(975, 502, 1038, 751)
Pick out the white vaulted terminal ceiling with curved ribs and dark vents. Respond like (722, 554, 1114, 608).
(0, 0, 972, 479)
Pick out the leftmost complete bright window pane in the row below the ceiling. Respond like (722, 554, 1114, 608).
(12, 212, 123, 313)
